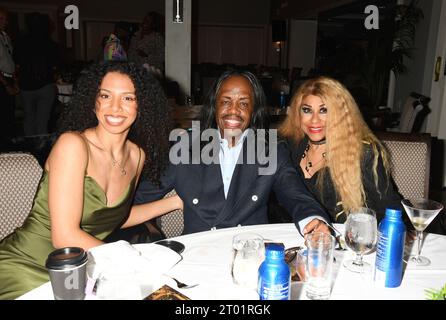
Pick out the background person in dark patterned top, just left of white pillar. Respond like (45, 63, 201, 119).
(129, 11, 164, 76)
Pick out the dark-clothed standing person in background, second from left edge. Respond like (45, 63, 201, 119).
(16, 12, 59, 136)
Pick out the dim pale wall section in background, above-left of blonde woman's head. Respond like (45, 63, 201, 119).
(288, 20, 317, 75)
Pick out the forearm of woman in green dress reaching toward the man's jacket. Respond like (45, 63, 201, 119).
(121, 196, 183, 228)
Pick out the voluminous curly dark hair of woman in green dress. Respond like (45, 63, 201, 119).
(58, 62, 170, 184)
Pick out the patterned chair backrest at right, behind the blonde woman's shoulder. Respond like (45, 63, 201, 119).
(376, 132, 431, 198)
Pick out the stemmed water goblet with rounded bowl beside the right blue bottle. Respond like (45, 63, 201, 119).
(344, 208, 378, 273)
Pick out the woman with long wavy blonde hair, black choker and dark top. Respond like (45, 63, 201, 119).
(279, 77, 401, 223)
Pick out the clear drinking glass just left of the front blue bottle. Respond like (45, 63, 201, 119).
(232, 233, 265, 291)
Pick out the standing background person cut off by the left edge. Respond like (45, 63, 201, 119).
(0, 7, 19, 147)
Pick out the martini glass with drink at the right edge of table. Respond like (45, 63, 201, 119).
(401, 198, 443, 266)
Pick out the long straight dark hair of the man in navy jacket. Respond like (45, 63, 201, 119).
(201, 70, 269, 130)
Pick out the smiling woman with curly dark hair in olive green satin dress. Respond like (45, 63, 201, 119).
(0, 63, 182, 299)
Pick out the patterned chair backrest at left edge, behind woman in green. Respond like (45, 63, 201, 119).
(0, 153, 42, 240)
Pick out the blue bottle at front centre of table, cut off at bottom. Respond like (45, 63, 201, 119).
(258, 243, 291, 300)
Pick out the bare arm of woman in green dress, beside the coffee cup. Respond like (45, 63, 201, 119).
(45, 133, 103, 250)
